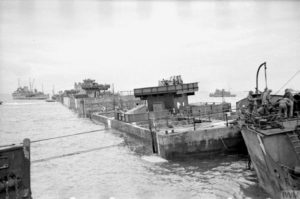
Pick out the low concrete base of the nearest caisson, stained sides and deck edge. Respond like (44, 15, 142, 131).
(91, 114, 246, 159)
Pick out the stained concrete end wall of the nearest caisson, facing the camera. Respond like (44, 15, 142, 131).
(157, 126, 245, 159)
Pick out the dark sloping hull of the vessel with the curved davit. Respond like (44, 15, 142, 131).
(241, 127, 299, 199)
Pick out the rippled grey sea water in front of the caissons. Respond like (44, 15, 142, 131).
(0, 97, 267, 199)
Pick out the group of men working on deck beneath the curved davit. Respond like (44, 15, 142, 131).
(247, 89, 294, 118)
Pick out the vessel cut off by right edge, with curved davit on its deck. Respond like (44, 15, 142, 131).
(237, 62, 300, 199)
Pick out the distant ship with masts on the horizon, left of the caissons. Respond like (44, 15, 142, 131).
(12, 86, 49, 100)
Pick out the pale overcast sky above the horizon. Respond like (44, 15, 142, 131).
(0, 0, 300, 94)
